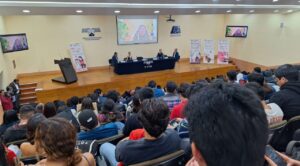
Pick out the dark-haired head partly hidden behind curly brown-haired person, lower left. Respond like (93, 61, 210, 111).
(26, 113, 47, 144)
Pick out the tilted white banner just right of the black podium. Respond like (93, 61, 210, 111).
(70, 43, 87, 72)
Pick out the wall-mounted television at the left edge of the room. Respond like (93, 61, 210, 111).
(0, 33, 28, 53)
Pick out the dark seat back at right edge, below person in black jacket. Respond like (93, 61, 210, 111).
(269, 116, 300, 152)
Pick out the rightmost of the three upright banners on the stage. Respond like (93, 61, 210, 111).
(218, 40, 229, 64)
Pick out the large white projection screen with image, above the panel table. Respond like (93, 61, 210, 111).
(117, 16, 157, 44)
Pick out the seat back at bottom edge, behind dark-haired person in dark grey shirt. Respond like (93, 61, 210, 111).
(130, 150, 185, 166)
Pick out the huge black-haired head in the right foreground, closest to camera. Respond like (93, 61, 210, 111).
(185, 83, 268, 166)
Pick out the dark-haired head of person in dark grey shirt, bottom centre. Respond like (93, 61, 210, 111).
(138, 98, 170, 138)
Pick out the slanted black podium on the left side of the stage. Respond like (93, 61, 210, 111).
(52, 58, 77, 84)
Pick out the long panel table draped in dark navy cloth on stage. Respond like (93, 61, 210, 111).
(114, 57, 175, 74)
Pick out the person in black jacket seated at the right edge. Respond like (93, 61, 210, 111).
(270, 64, 300, 120)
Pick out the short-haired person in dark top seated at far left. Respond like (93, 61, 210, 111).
(2, 105, 35, 143)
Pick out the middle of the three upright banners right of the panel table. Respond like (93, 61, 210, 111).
(203, 40, 215, 64)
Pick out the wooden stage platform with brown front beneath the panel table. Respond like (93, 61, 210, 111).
(18, 60, 236, 102)
